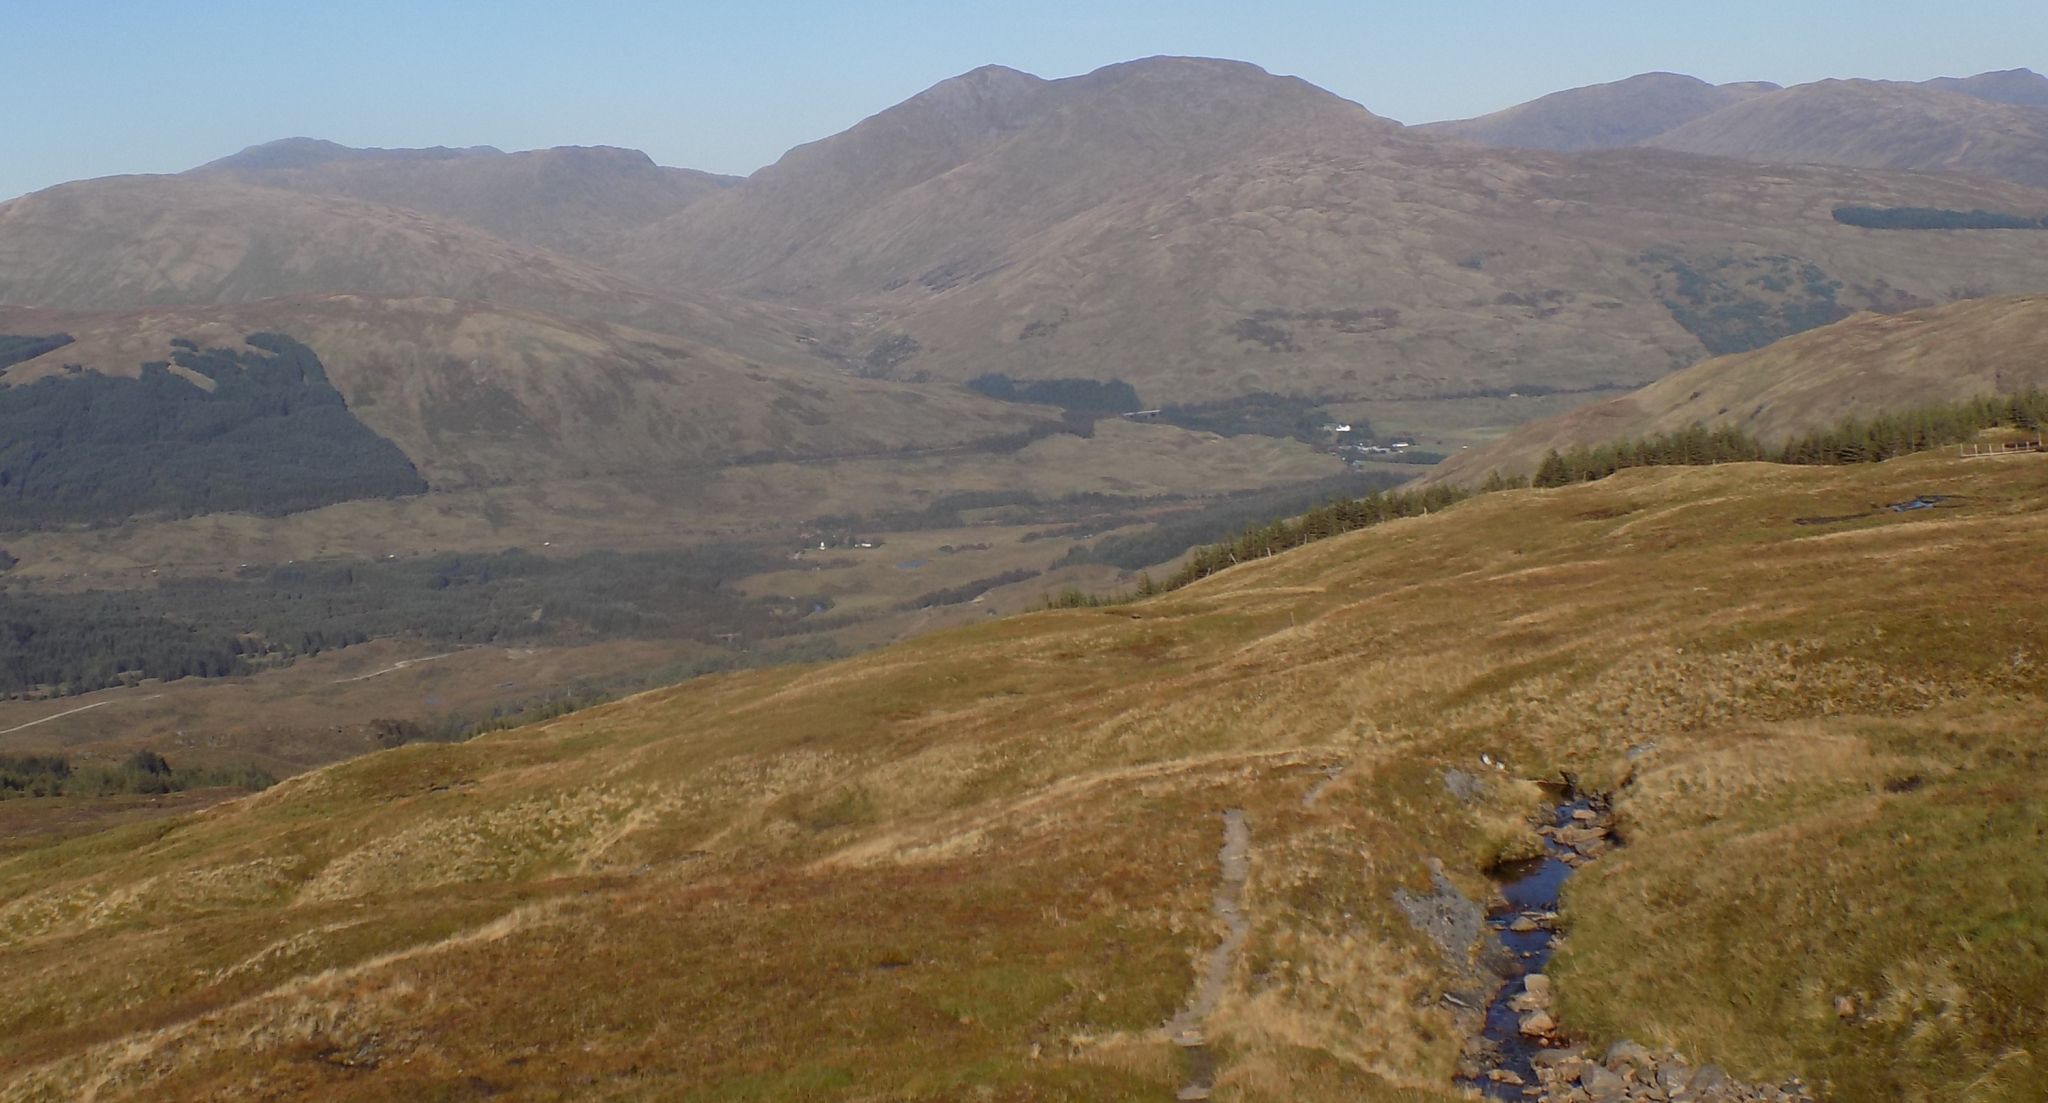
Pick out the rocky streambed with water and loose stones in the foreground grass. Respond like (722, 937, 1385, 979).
(1452, 788, 1812, 1103)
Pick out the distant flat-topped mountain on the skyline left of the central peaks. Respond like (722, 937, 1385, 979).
(186, 137, 735, 256)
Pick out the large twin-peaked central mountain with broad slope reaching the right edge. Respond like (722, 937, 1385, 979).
(616, 59, 2048, 405)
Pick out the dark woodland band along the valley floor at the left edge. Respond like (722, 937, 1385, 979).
(0, 544, 829, 694)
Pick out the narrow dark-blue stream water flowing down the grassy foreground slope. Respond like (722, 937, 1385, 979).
(1466, 794, 1606, 1101)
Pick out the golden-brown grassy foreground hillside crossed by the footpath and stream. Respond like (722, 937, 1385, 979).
(0, 456, 2048, 1101)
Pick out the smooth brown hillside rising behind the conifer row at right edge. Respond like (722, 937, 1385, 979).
(1430, 295, 2048, 483)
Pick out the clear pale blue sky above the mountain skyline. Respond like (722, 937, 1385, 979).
(0, 0, 2048, 198)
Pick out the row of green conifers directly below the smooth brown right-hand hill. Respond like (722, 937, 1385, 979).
(1532, 389, 2048, 487)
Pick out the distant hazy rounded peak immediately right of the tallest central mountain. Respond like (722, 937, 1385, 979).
(1415, 74, 1778, 151)
